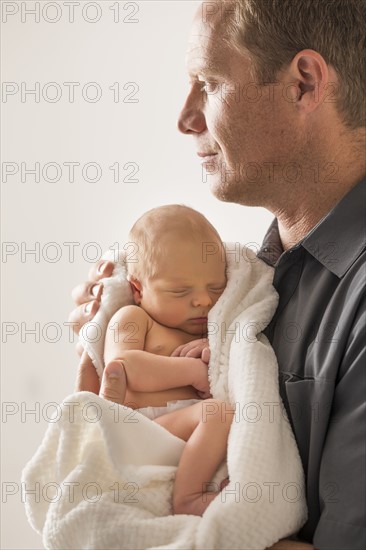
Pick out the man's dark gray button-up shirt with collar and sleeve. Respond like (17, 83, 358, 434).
(258, 180, 366, 550)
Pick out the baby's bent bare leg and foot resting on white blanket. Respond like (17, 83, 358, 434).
(155, 399, 234, 516)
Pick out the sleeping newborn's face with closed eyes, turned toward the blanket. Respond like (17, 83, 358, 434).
(141, 242, 226, 338)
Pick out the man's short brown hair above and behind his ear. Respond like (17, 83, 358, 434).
(223, 0, 366, 129)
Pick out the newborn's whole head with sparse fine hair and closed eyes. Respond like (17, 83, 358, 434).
(127, 205, 226, 337)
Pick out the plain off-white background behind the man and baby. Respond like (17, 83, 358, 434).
(1, 0, 271, 550)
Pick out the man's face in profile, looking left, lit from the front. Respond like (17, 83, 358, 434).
(178, 3, 302, 206)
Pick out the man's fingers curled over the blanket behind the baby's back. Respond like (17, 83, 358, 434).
(69, 260, 114, 355)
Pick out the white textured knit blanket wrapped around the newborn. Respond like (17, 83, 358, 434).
(22, 245, 307, 550)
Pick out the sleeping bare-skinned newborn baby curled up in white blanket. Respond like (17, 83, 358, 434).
(104, 205, 234, 515)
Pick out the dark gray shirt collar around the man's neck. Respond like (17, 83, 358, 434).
(258, 179, 366, 278)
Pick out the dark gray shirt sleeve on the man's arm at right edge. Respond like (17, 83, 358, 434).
(313, 300, 366, 550)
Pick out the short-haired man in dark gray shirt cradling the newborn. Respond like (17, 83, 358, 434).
(72, 0, 366, 550)
